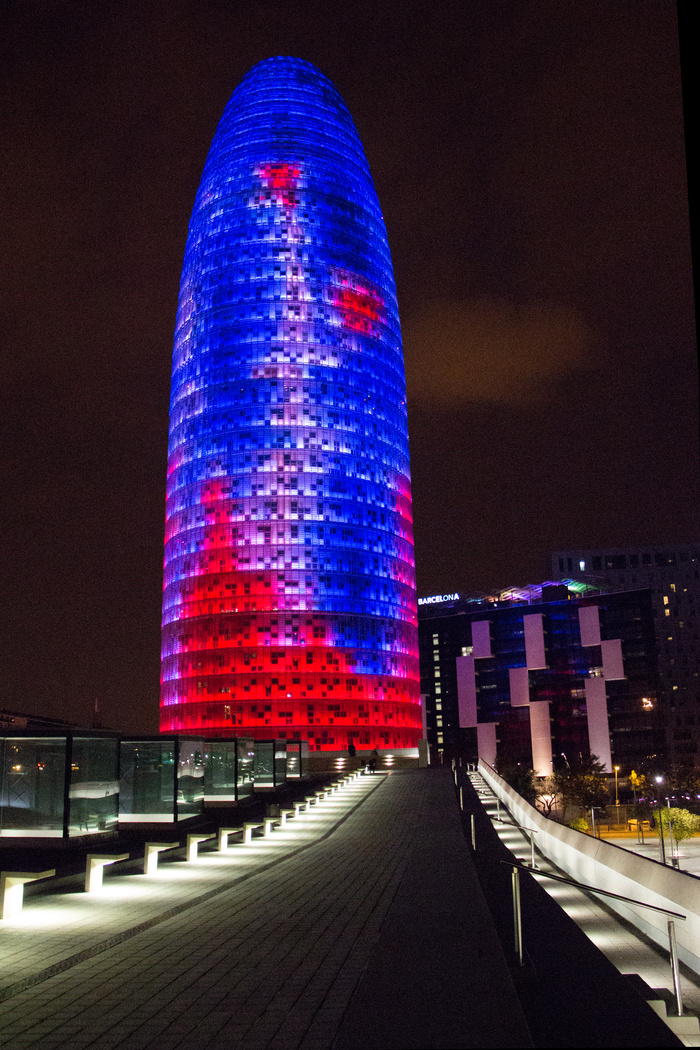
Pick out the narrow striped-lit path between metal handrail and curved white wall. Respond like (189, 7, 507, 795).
(469, 773, 700, 1033)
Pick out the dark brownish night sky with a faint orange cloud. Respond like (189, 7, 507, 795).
(0, 0, 700, 732)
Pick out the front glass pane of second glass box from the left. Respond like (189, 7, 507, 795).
(119, 737, 176, 823)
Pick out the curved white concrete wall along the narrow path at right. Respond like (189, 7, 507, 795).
(479, 762, 700, 973)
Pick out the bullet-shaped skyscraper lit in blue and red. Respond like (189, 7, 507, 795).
(161, 58, 421, 750)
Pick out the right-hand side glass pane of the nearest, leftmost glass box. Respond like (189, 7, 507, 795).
(68, 736, 119, 835)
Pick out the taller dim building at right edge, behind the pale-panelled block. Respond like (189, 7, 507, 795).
(552, 542, 700, 765)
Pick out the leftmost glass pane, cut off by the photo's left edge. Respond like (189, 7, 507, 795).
(0, 736, 66, 838)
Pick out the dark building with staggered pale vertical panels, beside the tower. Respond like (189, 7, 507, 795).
(419, 581, 663, 776)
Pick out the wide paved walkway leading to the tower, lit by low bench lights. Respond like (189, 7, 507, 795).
(0, 770, 531, 1050)
